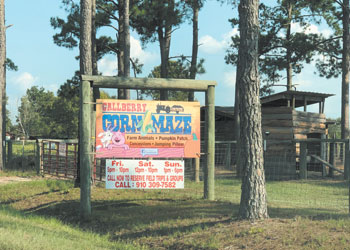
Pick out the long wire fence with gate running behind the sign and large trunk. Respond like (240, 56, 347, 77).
(7, 140, 349, 214)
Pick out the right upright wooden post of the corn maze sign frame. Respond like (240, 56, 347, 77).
(204, 86, 215, 200)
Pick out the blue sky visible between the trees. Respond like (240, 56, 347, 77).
(5, 0, 341, 121)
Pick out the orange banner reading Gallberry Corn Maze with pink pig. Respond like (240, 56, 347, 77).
(96, 99, 200, 158)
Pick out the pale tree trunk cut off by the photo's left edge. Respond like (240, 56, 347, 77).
(0, 0, 6, 171)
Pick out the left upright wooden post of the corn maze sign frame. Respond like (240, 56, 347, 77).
(80, 81, 91, 219)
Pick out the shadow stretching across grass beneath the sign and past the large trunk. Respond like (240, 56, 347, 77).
(14, 192, 349, 245)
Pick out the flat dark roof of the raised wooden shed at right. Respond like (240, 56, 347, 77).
(260, 90, 333, 108)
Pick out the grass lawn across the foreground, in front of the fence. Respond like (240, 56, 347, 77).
(0, 174, 350, 249)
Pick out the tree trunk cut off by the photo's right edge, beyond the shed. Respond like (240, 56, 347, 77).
(341, 0, 350, 143)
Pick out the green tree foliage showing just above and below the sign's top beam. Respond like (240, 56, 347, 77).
(141, 57, 205, 101)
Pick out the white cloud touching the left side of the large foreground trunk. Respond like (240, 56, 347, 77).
(199, 29, 238, 54)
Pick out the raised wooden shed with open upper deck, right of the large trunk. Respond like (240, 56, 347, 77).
(261, 91, 332, 178)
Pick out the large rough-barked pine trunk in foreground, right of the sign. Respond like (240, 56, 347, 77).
(237, 0, 268, 220)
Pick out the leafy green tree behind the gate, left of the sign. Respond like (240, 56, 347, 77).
(17, 84, 79, 139)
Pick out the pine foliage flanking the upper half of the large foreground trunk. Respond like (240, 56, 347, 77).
(225, 0, 325, 95)
